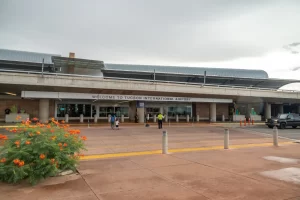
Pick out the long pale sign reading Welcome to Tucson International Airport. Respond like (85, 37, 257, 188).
(21, 91, 233, 103)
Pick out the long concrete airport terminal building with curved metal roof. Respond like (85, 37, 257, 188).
(0, 49, 300, 123)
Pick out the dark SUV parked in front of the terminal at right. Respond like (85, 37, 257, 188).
(266, 113, 300, 129)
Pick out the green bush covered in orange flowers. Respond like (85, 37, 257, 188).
(0, 119, 86, 184)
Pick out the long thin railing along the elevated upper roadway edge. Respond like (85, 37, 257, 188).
(0, 69, 300, 93)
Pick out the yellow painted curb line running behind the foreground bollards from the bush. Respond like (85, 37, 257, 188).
(80, 142, 294, 160)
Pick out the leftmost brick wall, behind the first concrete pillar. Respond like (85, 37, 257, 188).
(0, 99, 55, 121)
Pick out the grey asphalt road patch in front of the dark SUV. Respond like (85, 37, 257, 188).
(242, 125, 300, 140)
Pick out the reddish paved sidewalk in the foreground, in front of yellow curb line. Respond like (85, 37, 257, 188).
(0, 144, 300, 200)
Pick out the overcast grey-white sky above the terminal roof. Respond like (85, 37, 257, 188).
(0, 0, 300, 88)
